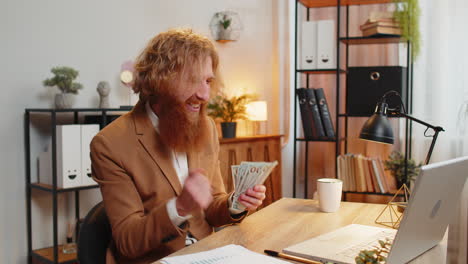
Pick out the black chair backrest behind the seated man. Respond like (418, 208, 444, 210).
(78, 202, 112, 264)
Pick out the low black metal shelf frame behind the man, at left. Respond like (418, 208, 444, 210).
(24, 107, 129, 264)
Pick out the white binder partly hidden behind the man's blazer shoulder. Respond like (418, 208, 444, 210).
(80, 125, 99, 186)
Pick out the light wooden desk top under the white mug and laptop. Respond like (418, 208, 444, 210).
(156, 198, 447, 264)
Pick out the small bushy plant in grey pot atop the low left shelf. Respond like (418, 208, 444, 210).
(43, 66, 83, 109)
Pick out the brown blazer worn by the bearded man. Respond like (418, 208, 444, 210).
(91, 102, 242, 263)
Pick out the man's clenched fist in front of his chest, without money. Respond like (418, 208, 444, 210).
(176, 169, 213, 216)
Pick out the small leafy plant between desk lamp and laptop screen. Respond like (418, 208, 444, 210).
(384, 151, 422, 189)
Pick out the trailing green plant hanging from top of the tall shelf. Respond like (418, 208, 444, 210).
(393, 0, 421, 61)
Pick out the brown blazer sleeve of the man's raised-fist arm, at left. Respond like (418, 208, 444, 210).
(91, 134, 186, 258)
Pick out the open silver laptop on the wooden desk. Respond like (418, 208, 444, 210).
(283, 156, 468, 264)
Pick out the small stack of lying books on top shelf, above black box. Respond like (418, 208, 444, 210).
(360, 12, 401, 37)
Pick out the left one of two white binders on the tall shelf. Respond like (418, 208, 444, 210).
(299, 21, 317, 70)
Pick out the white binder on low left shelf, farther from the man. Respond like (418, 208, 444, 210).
(56, 125, 81, 188)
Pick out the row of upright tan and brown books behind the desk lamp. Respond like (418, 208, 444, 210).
(337, 154, 397, 193)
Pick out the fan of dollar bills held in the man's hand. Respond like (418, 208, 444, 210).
(231, 160, 278, 213)
